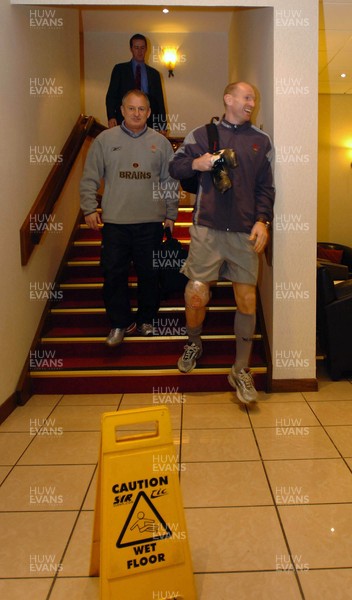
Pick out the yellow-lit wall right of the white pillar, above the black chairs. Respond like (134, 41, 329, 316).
(318, 94, 352, 246)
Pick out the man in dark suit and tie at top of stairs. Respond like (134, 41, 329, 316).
(106, 33, 167, 132)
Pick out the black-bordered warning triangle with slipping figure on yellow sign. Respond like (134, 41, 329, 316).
(116, 492, 172, 548)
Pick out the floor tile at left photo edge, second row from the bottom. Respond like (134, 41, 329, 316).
(0, 511, 77, 578)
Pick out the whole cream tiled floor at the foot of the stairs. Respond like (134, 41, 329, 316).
(0, 366, 352, 600)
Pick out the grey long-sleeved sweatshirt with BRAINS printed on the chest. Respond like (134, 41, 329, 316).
(80, 124, 179, 224)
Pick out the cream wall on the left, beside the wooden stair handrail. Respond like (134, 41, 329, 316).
(0, 0, 80, 404)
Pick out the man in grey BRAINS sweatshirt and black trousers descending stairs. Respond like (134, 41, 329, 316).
(80, 90, 178, 346)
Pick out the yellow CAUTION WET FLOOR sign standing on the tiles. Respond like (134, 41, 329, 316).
(90, 407, 197, 600)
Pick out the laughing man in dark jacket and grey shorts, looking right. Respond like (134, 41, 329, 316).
(170, 82, 274, 404)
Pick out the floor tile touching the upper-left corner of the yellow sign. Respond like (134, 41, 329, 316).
(50, 405, 116, 432)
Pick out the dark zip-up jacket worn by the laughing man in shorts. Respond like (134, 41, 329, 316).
(170, 119, 275, 233)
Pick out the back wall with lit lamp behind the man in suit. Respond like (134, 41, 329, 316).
(84, 30, 228, 137)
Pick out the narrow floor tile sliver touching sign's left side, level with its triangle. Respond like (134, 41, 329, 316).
(59, 511, 95, 577)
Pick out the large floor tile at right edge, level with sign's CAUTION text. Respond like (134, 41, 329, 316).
(265, 458, 352, 505)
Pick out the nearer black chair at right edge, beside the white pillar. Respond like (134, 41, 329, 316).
(317, 266, 352, 380)
